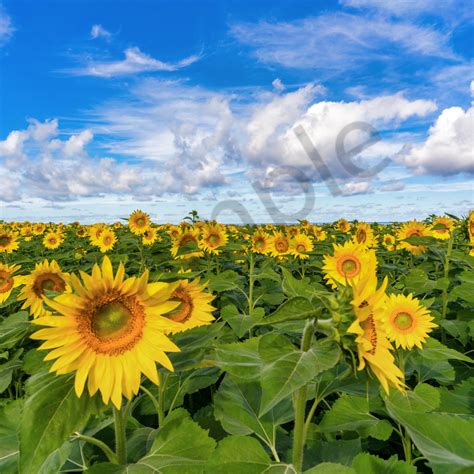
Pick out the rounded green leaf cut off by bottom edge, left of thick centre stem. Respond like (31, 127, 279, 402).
(205, 436, 296, 474)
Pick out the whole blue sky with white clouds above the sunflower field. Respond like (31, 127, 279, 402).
(0, 0, 474, 223)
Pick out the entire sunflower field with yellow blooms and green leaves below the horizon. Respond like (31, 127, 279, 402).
(0, 211, 474, 474)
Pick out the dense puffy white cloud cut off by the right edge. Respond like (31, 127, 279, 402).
(397, 107, 474, 176)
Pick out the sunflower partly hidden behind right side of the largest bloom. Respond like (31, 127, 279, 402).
(165, 278, 216, 333)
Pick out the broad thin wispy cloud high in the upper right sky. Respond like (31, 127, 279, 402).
(231, 12, 456, 71)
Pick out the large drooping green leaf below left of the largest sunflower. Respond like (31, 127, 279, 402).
(20, 373, 102, 474)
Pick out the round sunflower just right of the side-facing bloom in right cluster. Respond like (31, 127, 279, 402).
(383, 294, 437, 349)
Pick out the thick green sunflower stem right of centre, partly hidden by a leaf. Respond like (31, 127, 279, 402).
(293, 320, 315, 472)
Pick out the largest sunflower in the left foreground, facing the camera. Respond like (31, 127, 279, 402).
(31, 257, 179, 409)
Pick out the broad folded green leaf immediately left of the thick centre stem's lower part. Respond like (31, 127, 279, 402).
(214, 375, 293, 447)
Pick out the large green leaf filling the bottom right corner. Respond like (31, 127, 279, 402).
(385, 399, 474, 473)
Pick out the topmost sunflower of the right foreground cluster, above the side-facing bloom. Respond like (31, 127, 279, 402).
(322, 241, 377, 288)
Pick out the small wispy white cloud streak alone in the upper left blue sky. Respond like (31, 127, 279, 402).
(73, 47, 200, 77)
